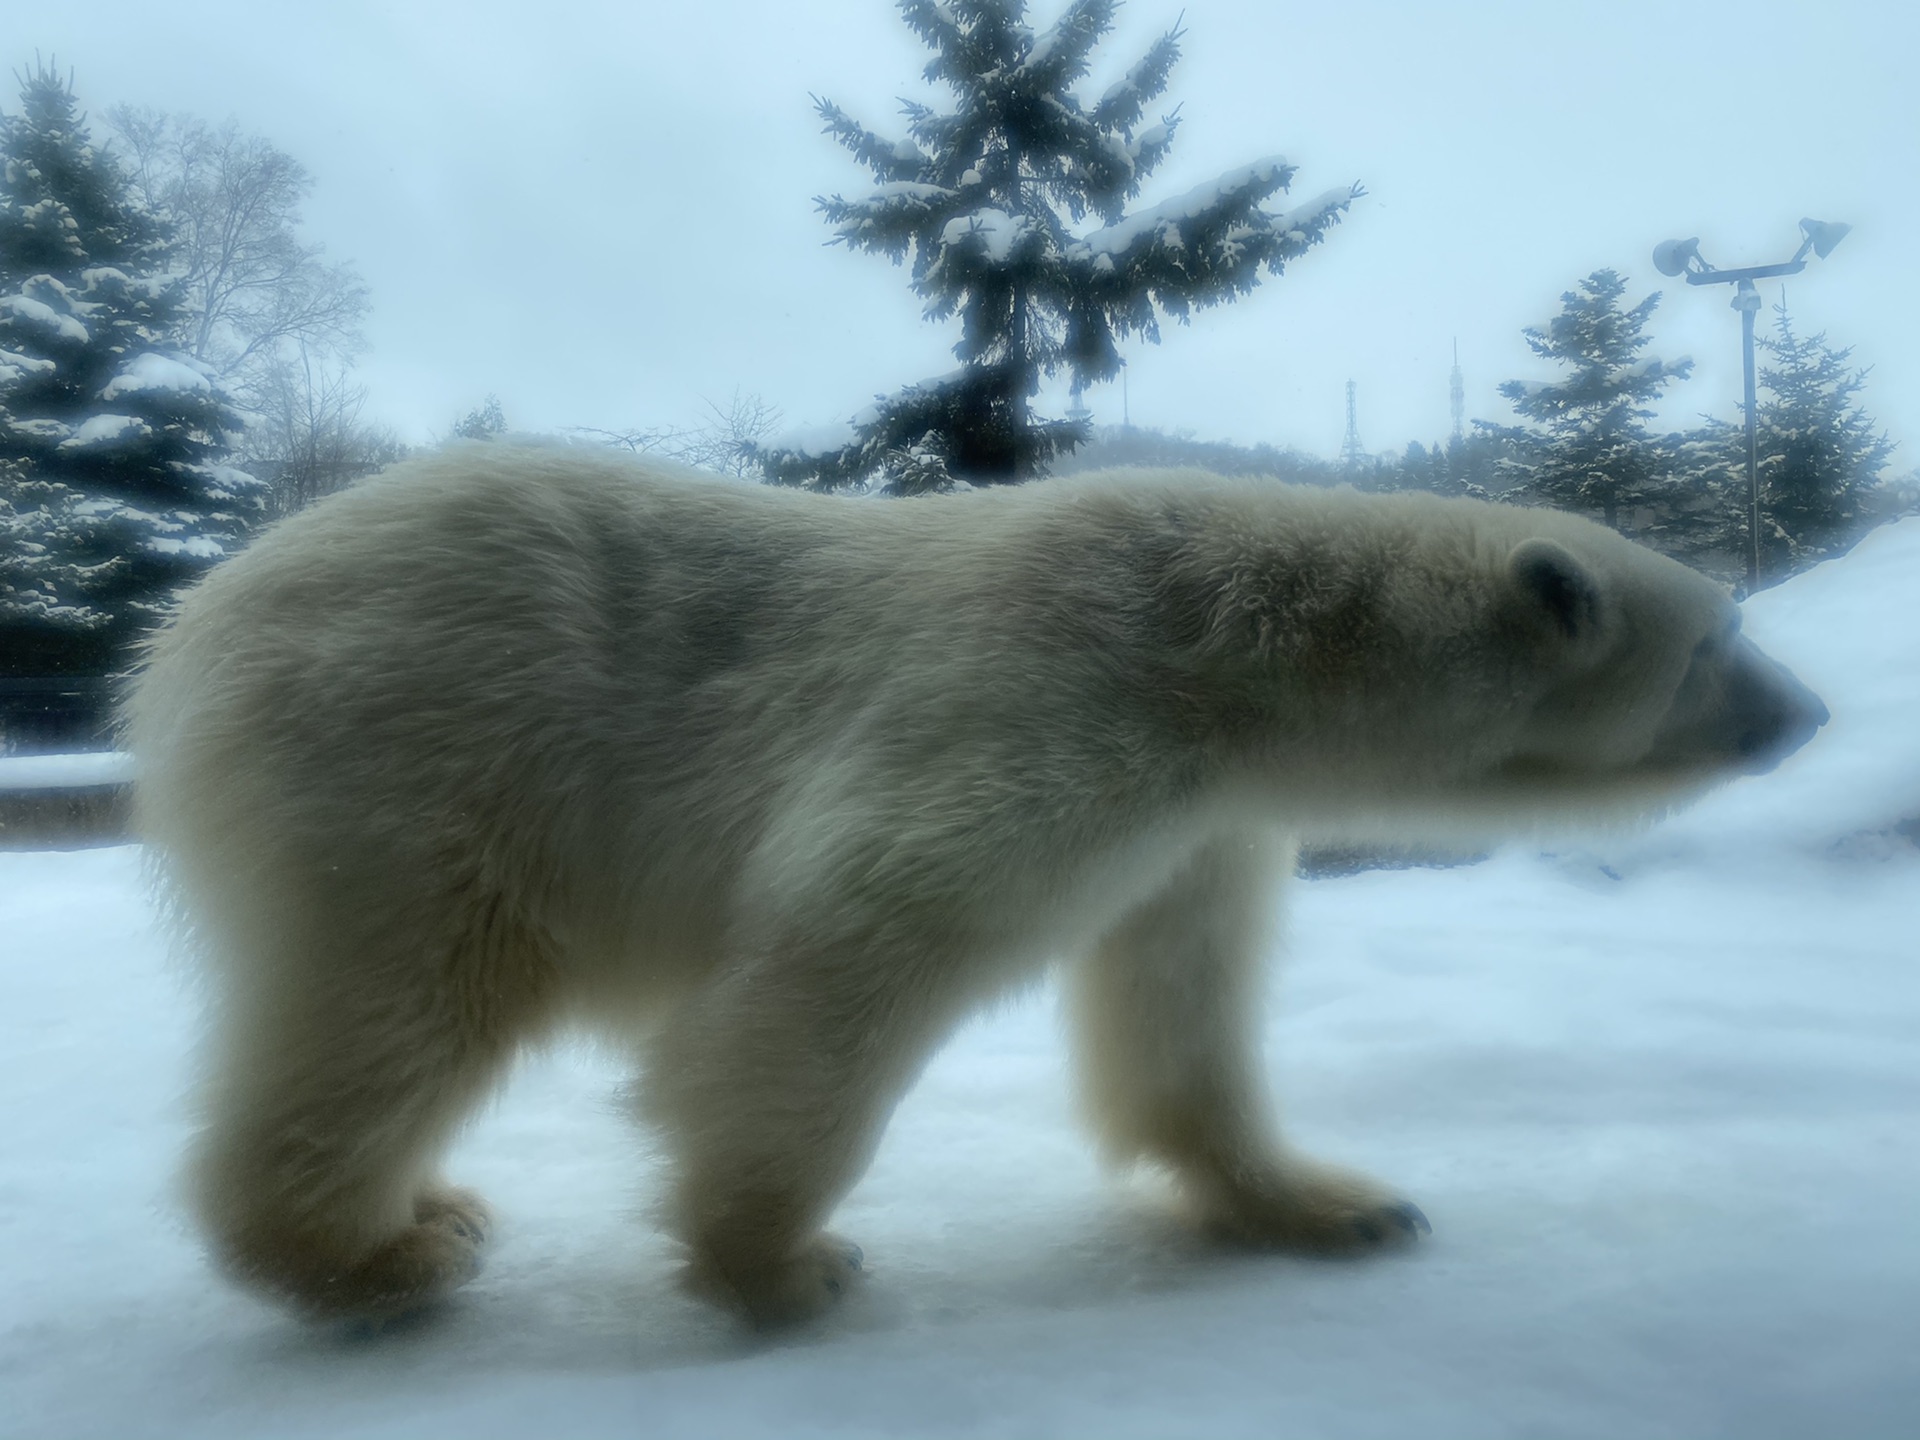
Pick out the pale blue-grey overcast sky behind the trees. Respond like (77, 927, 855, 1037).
(0, 0, 1920, 470)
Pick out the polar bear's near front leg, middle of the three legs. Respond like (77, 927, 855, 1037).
(645, 937, 964, 1325)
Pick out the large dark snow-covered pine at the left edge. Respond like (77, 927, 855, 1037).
(0, 65, 263, 676)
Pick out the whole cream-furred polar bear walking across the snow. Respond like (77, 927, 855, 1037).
(127, 445, 1826, 1321)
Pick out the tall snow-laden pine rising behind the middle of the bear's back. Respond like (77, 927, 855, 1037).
(760, 0, 1359, 493)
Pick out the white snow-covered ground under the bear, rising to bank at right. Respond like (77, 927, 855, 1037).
(0, 520, 1920, 1440)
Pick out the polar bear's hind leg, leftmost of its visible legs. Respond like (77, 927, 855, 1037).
(190, 906, 545, 1319)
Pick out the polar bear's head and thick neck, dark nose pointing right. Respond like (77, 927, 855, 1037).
(1150, 482, 1828, 837)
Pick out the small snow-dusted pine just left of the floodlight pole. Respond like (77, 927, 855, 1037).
(1475, 271, 1693, 541)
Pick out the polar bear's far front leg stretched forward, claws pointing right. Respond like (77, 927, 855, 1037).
(1071, 833, 1428, 1254)
